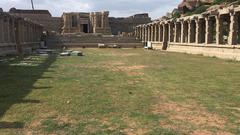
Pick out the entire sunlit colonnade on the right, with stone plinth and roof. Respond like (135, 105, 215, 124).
(135, 5, 240, 60)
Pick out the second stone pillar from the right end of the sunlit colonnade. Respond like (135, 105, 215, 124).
(215, 15, 223, 45)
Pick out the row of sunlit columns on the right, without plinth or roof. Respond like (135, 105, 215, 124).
(135, 12, 240, 45)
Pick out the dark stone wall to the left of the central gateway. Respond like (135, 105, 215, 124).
(9, 8, 62, 32)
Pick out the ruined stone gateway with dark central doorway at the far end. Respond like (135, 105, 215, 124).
(62, 11, 111, 35)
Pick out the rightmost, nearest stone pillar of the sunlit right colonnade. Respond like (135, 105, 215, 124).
(228, 13, 239, 45)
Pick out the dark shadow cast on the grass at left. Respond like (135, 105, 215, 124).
(0, 55, 57, 129)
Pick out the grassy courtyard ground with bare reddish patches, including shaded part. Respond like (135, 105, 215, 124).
(0, 49, 240, 135)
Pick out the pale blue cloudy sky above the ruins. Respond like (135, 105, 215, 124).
(0, 0, 181, 19)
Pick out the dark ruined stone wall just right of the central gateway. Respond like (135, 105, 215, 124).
(109, 13, 151, 35)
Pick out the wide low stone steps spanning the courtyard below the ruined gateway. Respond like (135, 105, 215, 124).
(47, 34, 143, 48)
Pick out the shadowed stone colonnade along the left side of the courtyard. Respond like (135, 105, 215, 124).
(0, 12, 43, 53)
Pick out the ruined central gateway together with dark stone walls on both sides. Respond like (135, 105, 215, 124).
(8, 8, 151, 35)
